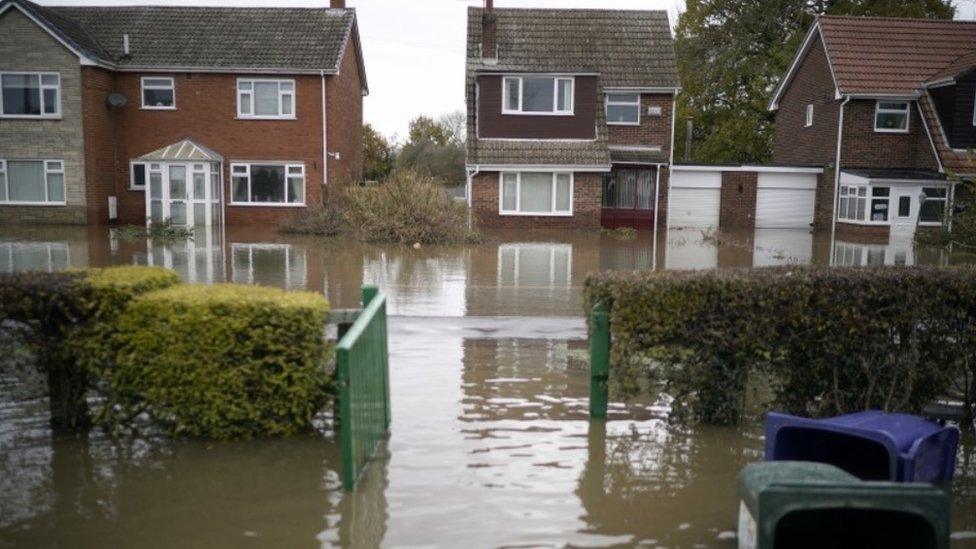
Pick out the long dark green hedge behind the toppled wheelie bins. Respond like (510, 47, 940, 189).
(585, 267, 976, 423)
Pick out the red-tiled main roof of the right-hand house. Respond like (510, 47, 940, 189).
(820, 15, 976, 95)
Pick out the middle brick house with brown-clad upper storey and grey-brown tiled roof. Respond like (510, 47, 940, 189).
(465, 0, 679, 228)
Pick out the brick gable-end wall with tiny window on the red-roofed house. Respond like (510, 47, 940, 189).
(773, 38, 840, 166)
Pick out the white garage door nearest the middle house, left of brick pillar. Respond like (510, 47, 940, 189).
(668, 170, 722, 228)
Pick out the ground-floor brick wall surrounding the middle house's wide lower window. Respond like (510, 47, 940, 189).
(471, 172, 603, 229)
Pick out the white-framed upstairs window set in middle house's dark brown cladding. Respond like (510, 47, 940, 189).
(502, 76, 575, 116)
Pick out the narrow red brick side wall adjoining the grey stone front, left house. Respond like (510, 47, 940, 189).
(81, 67, 121, 224)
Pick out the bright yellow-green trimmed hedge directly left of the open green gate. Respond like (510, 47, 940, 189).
(107, 285, 330, 439)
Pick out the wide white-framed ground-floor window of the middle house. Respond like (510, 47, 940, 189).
(499, 172, 573, 215)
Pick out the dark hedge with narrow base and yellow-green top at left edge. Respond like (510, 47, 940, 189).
(0, 267, 179, 429)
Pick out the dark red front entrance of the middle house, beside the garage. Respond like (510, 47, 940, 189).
(601, 168, 657, 230)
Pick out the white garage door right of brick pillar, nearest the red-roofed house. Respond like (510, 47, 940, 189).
(756, 172, 817, 229)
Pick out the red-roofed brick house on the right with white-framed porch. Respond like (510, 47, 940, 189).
(770, 16, 976, 240)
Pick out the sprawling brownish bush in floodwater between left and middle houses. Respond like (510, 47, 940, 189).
(280, 170, 478, 244)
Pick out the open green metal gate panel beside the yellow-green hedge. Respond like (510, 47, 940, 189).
(336, 286, 390, 491)
